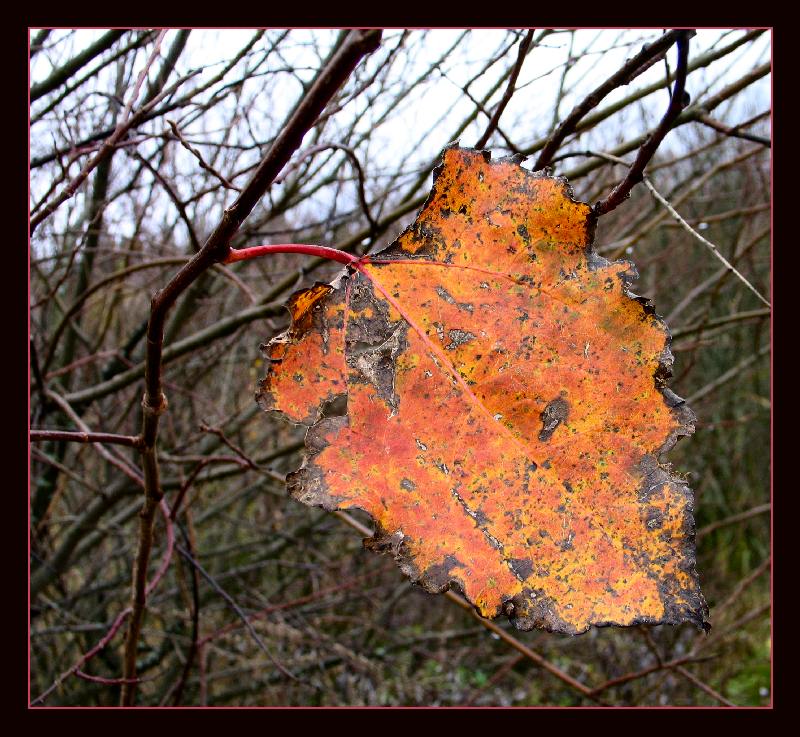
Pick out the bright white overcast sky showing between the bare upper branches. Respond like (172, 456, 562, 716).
(31, 29, 771, 250)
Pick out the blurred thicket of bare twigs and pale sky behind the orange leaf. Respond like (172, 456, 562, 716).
(30, 29, 771, 706)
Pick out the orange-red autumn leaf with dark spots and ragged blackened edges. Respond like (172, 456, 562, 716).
(258, 146, 708, 634)
